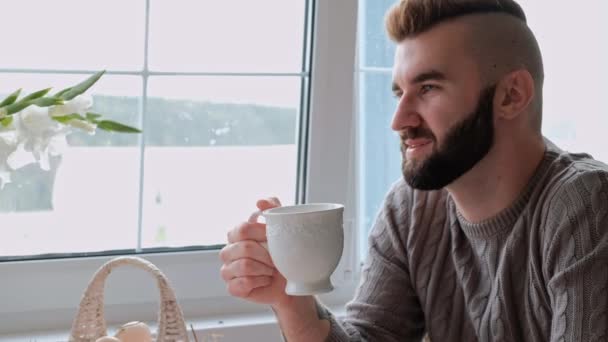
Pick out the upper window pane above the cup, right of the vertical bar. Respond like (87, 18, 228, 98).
(149, 0, 305, 72)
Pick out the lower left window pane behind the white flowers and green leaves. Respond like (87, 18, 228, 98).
(0, 74, 142, 256)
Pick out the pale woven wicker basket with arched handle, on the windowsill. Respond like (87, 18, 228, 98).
(70, 257, 188, 342)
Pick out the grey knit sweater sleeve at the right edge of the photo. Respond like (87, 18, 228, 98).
(543, 172, 608, 342)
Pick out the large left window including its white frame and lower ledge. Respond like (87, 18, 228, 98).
(0, 0, 357, 333)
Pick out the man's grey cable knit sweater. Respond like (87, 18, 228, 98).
(321, 145, 608, 342)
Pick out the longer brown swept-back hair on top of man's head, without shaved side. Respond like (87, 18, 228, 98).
(386, 0, 526, 42)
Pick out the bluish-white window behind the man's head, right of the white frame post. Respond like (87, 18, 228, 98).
(358, 0, 608, 250)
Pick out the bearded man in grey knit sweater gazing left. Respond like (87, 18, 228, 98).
(221, 0, 608, 342)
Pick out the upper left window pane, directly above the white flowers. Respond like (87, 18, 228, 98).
(0, 0, 145, 70)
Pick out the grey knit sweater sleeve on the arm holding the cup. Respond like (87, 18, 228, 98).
(325, 186, 425, 342)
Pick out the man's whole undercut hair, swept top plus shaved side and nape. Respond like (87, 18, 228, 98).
(385, 0, 544, 132)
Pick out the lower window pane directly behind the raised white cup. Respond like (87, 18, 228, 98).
(138, 77, 300, 247)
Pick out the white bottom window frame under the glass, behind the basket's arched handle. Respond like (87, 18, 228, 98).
(0, 251, 358, 334)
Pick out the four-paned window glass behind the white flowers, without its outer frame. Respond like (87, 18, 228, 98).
(0, 0, 309, 257)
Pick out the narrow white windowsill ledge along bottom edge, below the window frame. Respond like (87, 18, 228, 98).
(0, 304, 345, 342)
